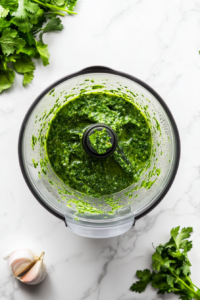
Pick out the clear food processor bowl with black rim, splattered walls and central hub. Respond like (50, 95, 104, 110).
(18, 66, 180, 238)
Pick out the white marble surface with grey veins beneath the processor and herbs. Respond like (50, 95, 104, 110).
(0, 0, 200, 300)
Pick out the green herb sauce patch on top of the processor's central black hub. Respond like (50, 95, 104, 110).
(89, 128, 112, 154)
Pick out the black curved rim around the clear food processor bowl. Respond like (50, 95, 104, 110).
(18, 66, 181, 220)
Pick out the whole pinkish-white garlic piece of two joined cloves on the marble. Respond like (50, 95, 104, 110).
(4, 249, 46, 285)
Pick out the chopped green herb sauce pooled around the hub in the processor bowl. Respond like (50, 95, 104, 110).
(46, 92, 152, 196)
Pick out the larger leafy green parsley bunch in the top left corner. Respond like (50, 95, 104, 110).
(0, 0, 77, 93)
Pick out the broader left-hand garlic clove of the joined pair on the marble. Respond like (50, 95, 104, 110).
(4, 249, 38, 277)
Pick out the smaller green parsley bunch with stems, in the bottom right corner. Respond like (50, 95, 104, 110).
(130, 227, 200, 300)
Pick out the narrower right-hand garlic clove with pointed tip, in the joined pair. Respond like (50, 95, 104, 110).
(18, 252, 46, 285)
